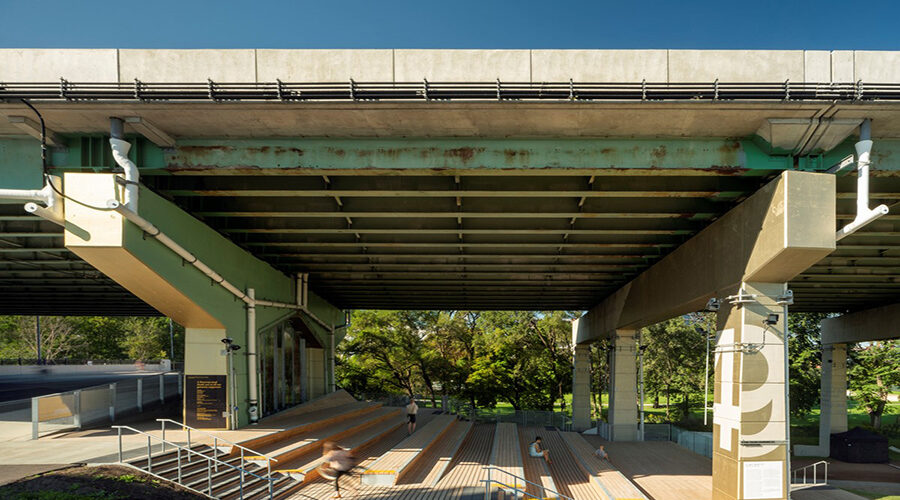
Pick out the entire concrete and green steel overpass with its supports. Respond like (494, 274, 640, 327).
(0, 50, 900, 498)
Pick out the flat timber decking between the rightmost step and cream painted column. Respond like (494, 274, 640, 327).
(583, 435, 712, 500)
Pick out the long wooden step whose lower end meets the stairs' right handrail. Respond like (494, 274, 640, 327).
(244, 407, 397, 468)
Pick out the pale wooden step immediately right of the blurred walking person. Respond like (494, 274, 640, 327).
(362, 415, 456, 486)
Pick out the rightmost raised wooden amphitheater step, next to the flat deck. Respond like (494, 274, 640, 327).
(559, 432, 647, 500)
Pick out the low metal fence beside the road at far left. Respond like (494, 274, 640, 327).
(0, 372, 183, 439)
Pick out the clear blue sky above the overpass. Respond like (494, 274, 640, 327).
(0, 0, 900, 50)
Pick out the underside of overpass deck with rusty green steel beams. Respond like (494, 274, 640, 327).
(0, 129, 900, 314)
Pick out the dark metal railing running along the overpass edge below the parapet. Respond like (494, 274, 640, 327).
(0, 78, 900, 102)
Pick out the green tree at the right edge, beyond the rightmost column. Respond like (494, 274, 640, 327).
(848, 340, 900, 429)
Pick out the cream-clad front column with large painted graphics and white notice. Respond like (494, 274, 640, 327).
(713, 282, 787, 500)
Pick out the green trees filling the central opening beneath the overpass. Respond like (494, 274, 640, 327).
(337, 311, 574, 409)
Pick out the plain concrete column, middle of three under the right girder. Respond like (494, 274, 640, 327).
(608, 330, 638, 441)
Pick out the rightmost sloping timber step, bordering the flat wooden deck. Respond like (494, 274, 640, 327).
(557, 432, 647, 500)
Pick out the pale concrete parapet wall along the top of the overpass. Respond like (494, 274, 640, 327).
(0, 49, 900, 83)
